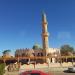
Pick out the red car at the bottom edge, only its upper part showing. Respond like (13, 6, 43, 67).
(20, 70, 52, 75)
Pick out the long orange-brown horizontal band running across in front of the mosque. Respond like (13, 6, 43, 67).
(0, 56, 75, 60)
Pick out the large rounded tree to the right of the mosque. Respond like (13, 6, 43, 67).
(60, 45, 74, 56)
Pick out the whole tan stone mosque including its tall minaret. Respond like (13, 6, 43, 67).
(15, 13, 60, 63)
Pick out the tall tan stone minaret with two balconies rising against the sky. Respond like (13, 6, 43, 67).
(42, 13, 49, 56)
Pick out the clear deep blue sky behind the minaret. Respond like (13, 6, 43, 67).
(0, 0, 75, 55)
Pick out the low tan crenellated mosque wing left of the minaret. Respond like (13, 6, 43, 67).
(15, 48, 43, 57)
